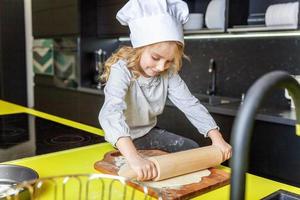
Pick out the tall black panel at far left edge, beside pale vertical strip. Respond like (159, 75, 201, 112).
(0, 0, 27, 106)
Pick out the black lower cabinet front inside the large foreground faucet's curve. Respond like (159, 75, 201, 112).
(249, 120, 300, 187)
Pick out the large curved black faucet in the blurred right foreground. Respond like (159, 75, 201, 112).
(230, 71, 300, 200)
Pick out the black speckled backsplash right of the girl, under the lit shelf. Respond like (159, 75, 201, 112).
(181, 37, 300, 107)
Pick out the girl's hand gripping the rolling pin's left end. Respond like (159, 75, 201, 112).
(128, 155, 158, 181)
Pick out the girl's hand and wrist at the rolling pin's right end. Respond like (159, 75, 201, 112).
(208, 129, 232, 161)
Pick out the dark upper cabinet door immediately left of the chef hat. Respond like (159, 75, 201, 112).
(97, 0, 129, 37)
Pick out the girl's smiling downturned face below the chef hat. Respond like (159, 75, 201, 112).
(140, 42, 177, 77)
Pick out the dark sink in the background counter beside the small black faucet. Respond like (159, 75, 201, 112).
(196, 95, 240, 105)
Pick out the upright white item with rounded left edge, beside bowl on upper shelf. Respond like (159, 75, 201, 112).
(205, 0, 225, 29)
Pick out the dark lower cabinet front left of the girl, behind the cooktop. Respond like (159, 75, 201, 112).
(34, 83, 104, 128)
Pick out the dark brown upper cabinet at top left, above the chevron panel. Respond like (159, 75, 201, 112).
(32, 0, 98, 38)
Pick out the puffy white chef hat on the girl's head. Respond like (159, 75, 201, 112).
(117, 0, 189, 48)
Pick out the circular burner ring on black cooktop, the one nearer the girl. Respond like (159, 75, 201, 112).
(45, 134, 91, 145)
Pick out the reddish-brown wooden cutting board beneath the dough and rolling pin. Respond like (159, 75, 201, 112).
(94, 150, 230, 200)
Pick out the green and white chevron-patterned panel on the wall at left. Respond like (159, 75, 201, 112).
(33, 38, 78, 87)
